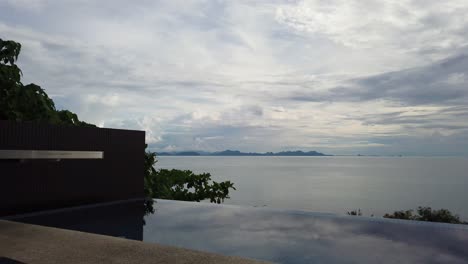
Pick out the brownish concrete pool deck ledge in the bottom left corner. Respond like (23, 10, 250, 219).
(0, 220, 266, 264)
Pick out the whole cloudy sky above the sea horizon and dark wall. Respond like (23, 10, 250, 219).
(0, 0, 468, 156)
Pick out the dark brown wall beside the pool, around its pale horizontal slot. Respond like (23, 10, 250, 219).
(0, 121, 145, 215)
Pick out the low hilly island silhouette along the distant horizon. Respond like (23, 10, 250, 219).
(157, 150, 332, 156)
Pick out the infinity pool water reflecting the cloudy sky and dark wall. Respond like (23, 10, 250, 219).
(3, 200, 468, 263)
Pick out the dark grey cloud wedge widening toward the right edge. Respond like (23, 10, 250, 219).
(289, 54, 468, 105)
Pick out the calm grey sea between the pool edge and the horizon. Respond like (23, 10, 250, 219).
(157, 157, 468, 220)
